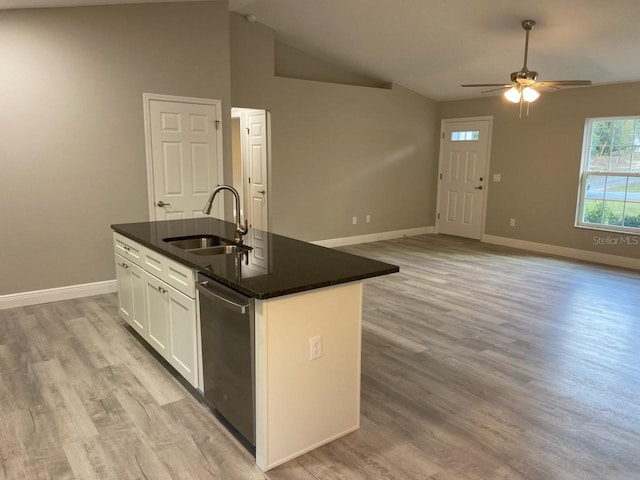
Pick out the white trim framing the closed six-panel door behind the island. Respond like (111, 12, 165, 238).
(142, 93, 224, 222)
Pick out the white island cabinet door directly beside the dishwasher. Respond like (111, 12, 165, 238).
(168, 287, 198, 386)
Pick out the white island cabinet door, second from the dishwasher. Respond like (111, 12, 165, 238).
(144, 272, 169, 359)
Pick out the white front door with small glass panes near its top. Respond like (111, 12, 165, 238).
(437, 118, 491, 239)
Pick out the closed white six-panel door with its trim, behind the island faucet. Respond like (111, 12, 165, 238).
(144, 94, 224, 220)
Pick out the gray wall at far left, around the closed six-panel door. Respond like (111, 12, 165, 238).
(0, 2, 230, 295)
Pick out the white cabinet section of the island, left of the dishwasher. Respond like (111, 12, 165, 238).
(114, 233, 199, 387)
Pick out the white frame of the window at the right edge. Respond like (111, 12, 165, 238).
(575, 114, 640, 235)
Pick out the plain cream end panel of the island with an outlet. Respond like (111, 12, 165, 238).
(255, 282, 362, 471)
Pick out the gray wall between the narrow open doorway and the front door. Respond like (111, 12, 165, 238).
(230, 14, 439, 240)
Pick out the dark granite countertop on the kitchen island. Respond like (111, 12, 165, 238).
(111, 217, 399, 299)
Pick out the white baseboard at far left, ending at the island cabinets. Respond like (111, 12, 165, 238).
(0, 280, 117, 310)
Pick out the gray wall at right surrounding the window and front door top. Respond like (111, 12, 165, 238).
(440, 83, 640, 258)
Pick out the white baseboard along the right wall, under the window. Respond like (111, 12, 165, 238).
(481, 235, 640, 270)
